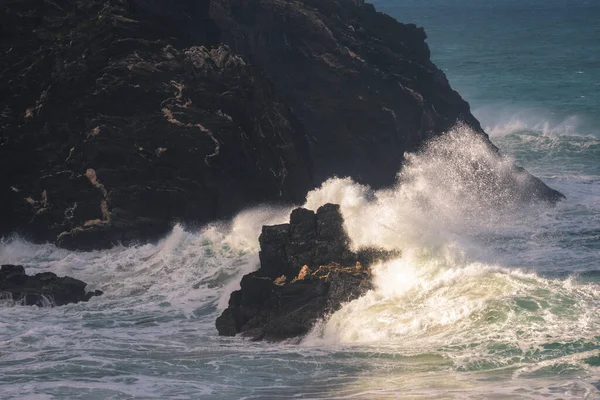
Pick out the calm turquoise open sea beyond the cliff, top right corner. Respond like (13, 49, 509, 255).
(375, 0, 600, 133)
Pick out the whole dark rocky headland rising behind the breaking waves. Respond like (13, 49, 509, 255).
(0, 0, 560, 249)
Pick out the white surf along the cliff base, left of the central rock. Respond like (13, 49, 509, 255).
(0, 207, 289, 315)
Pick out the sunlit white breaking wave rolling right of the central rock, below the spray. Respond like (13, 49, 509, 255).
(305, 249, 600, 370)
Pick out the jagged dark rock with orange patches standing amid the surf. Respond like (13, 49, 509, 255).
(216, 204, 398, 341)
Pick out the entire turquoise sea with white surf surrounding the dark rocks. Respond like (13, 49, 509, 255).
(0, 0, 600, 400)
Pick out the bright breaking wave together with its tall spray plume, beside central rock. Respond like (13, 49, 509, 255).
(304, 127, 600, 376)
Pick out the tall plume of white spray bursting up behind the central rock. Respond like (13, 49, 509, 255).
(305, 126, 546, 253)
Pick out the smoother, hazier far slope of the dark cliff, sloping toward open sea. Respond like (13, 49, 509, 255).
(213, 0, 483, 188)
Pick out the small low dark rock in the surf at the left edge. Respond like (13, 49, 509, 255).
(0, 265, 102, 307)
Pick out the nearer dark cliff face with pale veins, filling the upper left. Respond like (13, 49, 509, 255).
(0, 0, 312, 250)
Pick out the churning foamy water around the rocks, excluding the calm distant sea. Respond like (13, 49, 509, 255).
(0, 123, 600, 398)
